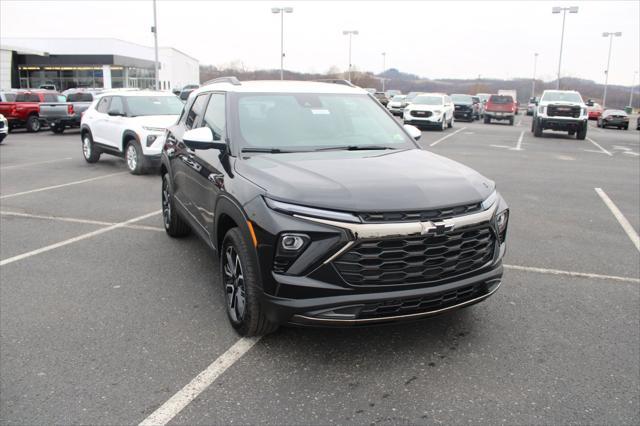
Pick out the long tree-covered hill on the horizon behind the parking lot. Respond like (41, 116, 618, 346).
(200, 65, 640, 108)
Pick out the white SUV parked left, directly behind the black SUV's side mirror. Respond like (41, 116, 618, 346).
(80, 90, 184, 174)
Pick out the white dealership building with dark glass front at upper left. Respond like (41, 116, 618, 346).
(0, 37, 200, 91)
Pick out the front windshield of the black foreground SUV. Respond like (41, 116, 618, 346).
(232, 93, 415, 151)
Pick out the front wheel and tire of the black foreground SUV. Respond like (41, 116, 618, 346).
(220, 228, 278, 336)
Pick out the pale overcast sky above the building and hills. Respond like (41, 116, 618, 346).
(0, 0, 640, 85)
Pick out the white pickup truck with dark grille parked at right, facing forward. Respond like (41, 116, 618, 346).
(531, 90, 589, 139)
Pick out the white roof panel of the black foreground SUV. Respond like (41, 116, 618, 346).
(192, 80, 369, 96)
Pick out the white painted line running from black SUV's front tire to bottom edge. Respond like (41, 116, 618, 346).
(140, 337, 260, 426)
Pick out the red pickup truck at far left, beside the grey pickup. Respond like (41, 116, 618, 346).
(0, 90, 64, 132)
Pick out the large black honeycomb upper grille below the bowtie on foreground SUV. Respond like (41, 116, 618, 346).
(333, 224, 496, 286)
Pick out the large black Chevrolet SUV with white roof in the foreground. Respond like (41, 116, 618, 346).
(161, 77, 509, 335)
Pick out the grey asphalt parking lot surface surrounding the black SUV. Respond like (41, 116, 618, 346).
(0, 115, 640, 424)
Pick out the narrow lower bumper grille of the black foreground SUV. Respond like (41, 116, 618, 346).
(358, 283, 486, 319)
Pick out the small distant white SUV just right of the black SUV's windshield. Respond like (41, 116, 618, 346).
(403, 93, 454, 130)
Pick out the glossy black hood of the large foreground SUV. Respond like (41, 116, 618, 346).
(236, 149, 494, 212)
